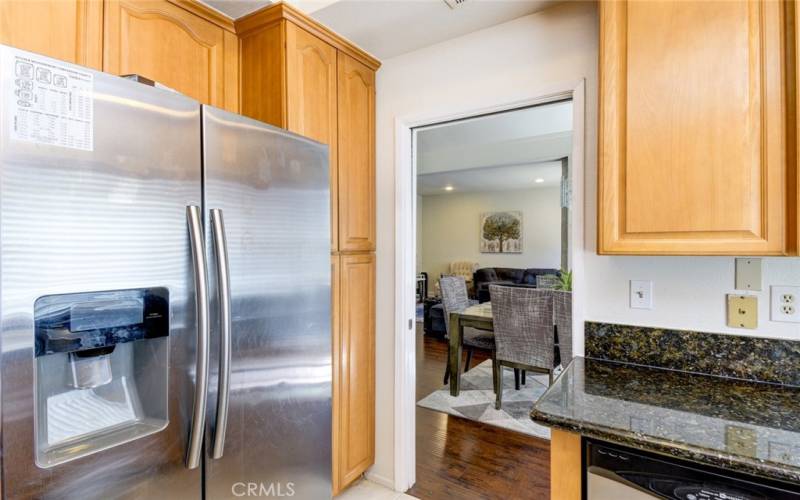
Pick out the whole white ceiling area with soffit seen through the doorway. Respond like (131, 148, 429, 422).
(415, 101, 572, 195)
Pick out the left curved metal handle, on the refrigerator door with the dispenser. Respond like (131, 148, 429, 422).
(186, 205, 209, 469)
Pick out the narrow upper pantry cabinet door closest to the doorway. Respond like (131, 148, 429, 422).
(338, 52, 375, 251)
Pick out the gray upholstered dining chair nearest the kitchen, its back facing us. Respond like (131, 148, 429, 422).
(489, 285, 572, 410)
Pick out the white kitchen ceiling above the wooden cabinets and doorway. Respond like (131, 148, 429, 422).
(201, 0, 557, 59)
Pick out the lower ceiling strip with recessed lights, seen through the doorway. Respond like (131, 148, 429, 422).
(417, 161, 561, 196)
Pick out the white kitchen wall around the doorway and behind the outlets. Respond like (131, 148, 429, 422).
(371, 2, 800, 482)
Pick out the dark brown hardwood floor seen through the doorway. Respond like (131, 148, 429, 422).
(407, 323, 550, 500)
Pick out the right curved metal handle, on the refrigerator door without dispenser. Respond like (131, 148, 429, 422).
(211, 208, 231, 459)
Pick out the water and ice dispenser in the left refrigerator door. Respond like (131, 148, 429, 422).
(34, 288, 169, 467)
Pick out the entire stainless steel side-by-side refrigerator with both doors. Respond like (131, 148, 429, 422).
(0, 46, 331, 499)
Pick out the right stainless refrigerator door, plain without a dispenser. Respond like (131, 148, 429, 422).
(203, 106, 331, 500)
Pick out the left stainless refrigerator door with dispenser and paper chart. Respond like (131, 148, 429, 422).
(0, 46, 202, 499)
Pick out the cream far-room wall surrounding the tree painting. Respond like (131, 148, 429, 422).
(417, 186, 561, 284)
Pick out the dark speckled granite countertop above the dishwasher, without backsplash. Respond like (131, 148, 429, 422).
(531, 358, 800, 483)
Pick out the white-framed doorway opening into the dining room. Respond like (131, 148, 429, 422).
(395, 83, 583, 497)
